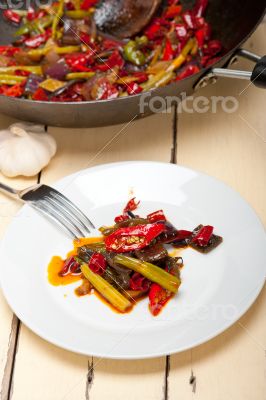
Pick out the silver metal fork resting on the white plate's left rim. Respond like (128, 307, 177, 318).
(0, 182, 95, 239)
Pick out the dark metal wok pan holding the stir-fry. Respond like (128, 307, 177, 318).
(0, 0, 266, 127)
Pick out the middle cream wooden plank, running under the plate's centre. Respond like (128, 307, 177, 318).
(9, 114, 172, 400)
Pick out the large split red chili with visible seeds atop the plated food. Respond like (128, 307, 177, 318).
(105, 223, 165, 253)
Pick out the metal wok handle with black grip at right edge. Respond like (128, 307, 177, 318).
(196, 49, 266, 89)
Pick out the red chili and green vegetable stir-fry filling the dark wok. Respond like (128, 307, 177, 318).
(0, 0, 222, 102)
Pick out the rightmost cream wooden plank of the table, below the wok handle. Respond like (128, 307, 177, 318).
(169, 24, 266, 400)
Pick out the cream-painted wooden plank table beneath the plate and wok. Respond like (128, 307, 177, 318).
(0, 23, 266, 400)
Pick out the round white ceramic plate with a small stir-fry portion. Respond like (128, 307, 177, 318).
(0, 162, 266, 359)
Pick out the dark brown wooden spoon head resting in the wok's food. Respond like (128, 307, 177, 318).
(94, 0, 161, 39)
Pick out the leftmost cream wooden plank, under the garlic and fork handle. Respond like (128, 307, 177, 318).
(0, 115, 37, 400)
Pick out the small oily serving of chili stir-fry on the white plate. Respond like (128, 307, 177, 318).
(48, 198, 222, 316)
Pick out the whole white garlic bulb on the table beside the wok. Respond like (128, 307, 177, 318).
(0, 123, 56, 177)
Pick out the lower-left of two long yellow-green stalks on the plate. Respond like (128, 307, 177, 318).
(81, 264, 132, 312)
